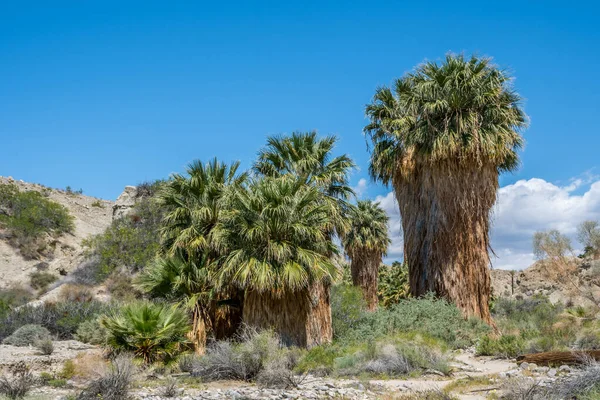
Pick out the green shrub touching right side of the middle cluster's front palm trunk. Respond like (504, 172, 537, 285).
(331, 284, 367, 337)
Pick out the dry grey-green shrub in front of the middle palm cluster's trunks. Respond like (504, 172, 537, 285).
(192, 329, 281, 381)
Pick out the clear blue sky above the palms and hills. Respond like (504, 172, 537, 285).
(0, 1, 600, 268)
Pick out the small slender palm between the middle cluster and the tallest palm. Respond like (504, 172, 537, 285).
(342, 200, 390, 311)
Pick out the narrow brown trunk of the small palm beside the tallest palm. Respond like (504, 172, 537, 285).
(350, 250, 381, 311)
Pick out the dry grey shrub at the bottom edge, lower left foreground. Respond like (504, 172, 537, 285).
(77, 356, 135, 400)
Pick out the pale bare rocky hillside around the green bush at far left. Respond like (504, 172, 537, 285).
(0, 177, 115, 288)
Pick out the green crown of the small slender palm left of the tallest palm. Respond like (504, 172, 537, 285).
(342, 200, 390, 258)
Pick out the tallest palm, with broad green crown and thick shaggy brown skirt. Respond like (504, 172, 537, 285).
(364, 55, 527, 323)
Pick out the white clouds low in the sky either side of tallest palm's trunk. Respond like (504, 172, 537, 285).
(377, 175, 600, 269)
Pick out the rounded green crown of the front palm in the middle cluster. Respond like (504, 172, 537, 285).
(215, 176, 337, 295)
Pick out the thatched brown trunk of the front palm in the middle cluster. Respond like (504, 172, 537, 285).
(243, 283, 333, 347)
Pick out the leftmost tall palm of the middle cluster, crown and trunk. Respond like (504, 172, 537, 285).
(155, 159, 248, 352)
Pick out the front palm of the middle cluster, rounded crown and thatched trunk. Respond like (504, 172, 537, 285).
(214, 175, 337, 346)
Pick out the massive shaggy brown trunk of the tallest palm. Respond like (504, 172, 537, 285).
(394, 164, 498, 323)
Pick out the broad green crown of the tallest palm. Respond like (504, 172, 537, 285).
(364, 55, 527, 184)
